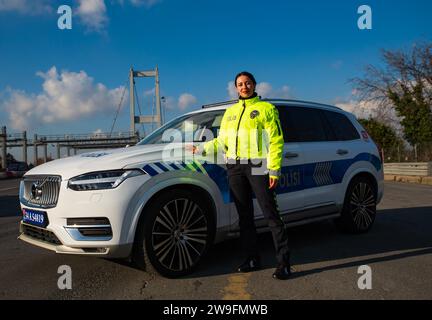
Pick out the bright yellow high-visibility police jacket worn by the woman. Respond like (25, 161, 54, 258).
(203, 97, 284, 178)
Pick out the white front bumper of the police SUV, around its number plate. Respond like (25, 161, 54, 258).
(18, 176, 148, 258)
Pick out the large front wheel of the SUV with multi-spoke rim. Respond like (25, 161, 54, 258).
(133, 189, 215, 278)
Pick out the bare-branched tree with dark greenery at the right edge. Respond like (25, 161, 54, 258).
(351, 43, 432, 158)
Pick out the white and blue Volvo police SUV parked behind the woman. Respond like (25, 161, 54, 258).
(19, 100, 383, 277)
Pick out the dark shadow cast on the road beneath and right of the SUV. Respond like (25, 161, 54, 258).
(188, 207, 432, 278)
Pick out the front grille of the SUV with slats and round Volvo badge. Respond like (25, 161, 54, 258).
(22, 176, 61, 208)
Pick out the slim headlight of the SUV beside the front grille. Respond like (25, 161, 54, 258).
(68, 170, 145, 191)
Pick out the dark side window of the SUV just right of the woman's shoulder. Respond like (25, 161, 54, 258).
(278, 106, 329, 142)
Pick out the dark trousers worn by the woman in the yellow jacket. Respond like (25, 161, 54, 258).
(227, 161, 289, 263)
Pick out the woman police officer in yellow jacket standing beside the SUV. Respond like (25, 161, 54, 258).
(193, 71, 291, 279)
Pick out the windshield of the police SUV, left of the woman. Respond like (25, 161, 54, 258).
(138, 110, 225, 145)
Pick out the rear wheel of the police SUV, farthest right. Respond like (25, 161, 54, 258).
(335, 177, 377, 233)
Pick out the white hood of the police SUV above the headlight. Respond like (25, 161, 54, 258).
(26, 144, 183, 180)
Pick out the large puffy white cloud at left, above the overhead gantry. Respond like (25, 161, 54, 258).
(1, 67, 124, 130)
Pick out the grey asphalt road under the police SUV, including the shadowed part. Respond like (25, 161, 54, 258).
(0, 180, 432, 300)
